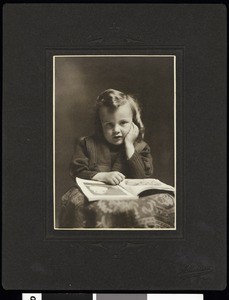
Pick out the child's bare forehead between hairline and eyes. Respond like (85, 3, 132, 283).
(99, 103, 133, 121)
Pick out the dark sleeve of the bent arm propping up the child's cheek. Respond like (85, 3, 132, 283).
(127, 144, 153, 178)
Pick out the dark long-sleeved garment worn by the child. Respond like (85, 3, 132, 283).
(70, 136, 153, 180)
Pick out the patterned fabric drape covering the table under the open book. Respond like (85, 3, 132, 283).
(60, 187, 174, 228)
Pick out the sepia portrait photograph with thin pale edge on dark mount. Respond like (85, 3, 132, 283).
(53, 55, 176, 230)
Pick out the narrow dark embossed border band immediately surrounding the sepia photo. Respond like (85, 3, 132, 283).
(44, 45, 185, 241)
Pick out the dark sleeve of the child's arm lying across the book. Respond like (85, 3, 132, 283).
(70, 138, 98, 181)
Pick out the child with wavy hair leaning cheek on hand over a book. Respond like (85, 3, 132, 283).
(70, 89, 153, 185)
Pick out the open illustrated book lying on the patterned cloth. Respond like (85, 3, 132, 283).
(76, 177, 175, 201)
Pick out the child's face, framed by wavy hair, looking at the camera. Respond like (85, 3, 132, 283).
(99, 103, 133, 145)
